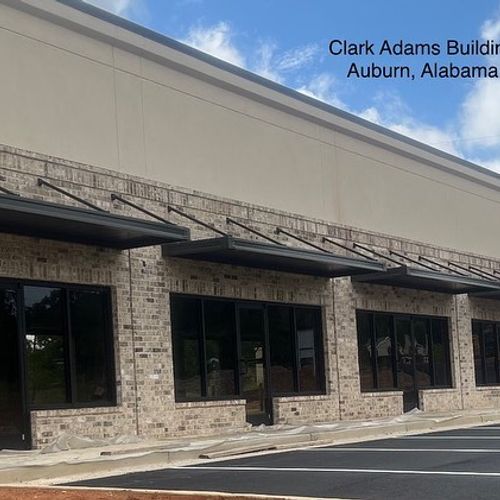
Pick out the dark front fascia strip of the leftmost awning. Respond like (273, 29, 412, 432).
(0, 194, 190, 240)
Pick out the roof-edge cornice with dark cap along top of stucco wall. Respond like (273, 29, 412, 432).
(0, 0, 500, 190)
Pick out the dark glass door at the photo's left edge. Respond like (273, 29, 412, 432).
(0, 287, 28, 448)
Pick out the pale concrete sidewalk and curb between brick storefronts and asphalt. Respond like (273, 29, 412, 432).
(0, 413, 500, 484)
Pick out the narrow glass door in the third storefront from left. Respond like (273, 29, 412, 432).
(394, 318, 418, 412)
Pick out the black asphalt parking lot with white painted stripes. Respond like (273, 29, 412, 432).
(64, 425, 500, 500)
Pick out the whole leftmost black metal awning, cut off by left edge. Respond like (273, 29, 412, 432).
(0, 194, 189, 249)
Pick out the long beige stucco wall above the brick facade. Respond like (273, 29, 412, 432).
(0, 0, 500, 257)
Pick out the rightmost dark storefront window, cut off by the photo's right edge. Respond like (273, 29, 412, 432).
(472, 320, 500, 385)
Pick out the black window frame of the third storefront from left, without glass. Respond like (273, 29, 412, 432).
(356, 309, 453, 393)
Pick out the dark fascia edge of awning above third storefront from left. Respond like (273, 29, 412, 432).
(351, 266, 500, 293)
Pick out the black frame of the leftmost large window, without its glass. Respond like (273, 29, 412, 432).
(0, 278, 117, 412)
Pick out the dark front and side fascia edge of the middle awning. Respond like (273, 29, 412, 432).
(163, 236, 385, 271)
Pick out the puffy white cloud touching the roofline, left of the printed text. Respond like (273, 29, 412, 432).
(184, 22, 246, 68)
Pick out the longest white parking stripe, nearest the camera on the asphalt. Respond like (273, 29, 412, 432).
(179, 465, 500, 477)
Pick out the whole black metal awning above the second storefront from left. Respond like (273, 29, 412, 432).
(163, 235, 385, 278)
